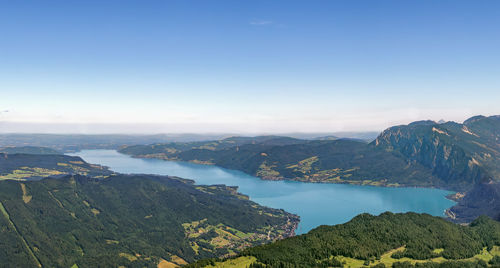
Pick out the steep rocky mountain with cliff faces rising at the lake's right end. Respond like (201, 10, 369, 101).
(372, 116, 500, 190)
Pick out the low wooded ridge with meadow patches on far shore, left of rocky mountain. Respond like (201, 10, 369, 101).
(120, 137, 439, 187)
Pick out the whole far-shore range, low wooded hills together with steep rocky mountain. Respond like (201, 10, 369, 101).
(120, 116, 500, 191)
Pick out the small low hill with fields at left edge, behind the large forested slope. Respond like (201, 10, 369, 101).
(0, 153, 112, 181)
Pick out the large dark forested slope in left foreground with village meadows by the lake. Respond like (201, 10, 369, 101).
(0, 175, 298, 267)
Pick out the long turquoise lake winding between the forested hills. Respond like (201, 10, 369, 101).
(73, 150, 455, 234)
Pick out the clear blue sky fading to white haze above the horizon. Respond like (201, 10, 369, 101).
(0, 0, 500, 133)
